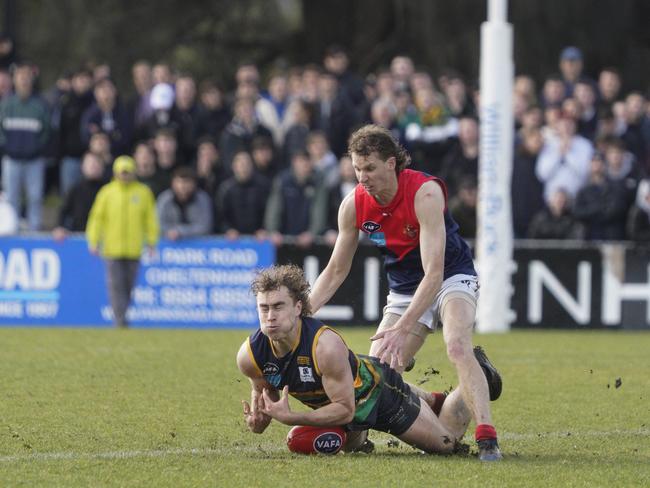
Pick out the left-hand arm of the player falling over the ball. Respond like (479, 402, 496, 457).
(237, 339, 279, 434)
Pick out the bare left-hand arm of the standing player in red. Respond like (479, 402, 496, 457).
(309, 192, 359, 313)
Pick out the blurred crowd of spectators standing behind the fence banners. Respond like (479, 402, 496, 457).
(0, 46, 650, 246)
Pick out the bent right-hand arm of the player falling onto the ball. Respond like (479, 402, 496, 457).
(264, 330, 355, 427)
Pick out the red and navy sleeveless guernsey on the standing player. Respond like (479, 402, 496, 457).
(354, 169, 476, 295)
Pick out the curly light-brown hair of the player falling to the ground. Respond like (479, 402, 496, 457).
(251, 264, 311, 317)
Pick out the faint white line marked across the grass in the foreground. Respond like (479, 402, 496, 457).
(0, 428, 650, 464)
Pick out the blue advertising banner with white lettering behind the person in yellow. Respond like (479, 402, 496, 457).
(0, 237, 275, 328)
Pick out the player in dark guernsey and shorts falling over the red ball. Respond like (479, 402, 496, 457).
(237, 265, 498, 453)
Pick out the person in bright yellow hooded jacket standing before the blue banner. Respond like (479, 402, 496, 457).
(86, 156, 160, 327)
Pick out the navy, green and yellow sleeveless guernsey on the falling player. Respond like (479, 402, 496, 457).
(248, 317, 384, 429)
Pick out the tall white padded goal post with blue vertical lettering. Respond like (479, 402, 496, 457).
(476, 0, 514, 332)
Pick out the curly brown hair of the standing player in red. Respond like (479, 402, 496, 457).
(348, 124, 411, 174)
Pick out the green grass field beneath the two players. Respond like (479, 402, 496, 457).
(0, 328, 650, 487)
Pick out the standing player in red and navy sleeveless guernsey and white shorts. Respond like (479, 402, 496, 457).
(310, 125, 501, 461)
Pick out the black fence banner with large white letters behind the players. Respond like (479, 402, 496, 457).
(277, 241, 650, 330)
